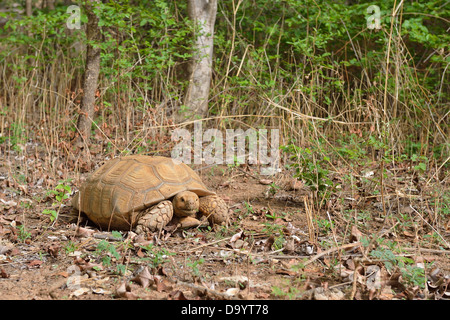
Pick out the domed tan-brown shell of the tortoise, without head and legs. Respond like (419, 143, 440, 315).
(72, 155, 215, 230)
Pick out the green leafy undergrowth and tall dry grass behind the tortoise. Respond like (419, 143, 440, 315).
(0, 0, 450, 300)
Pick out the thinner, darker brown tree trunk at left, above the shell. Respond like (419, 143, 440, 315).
(75, 0, 101, 146)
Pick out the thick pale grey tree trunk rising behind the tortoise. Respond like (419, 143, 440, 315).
(180, 0, 217, 118)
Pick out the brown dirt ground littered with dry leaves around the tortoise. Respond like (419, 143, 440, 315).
(0, 140, 450, 300)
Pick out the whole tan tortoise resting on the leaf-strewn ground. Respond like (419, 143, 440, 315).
(72, 155, 228, 233)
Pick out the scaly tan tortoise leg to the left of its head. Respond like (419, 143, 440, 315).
(136, 200, 173, 233)
